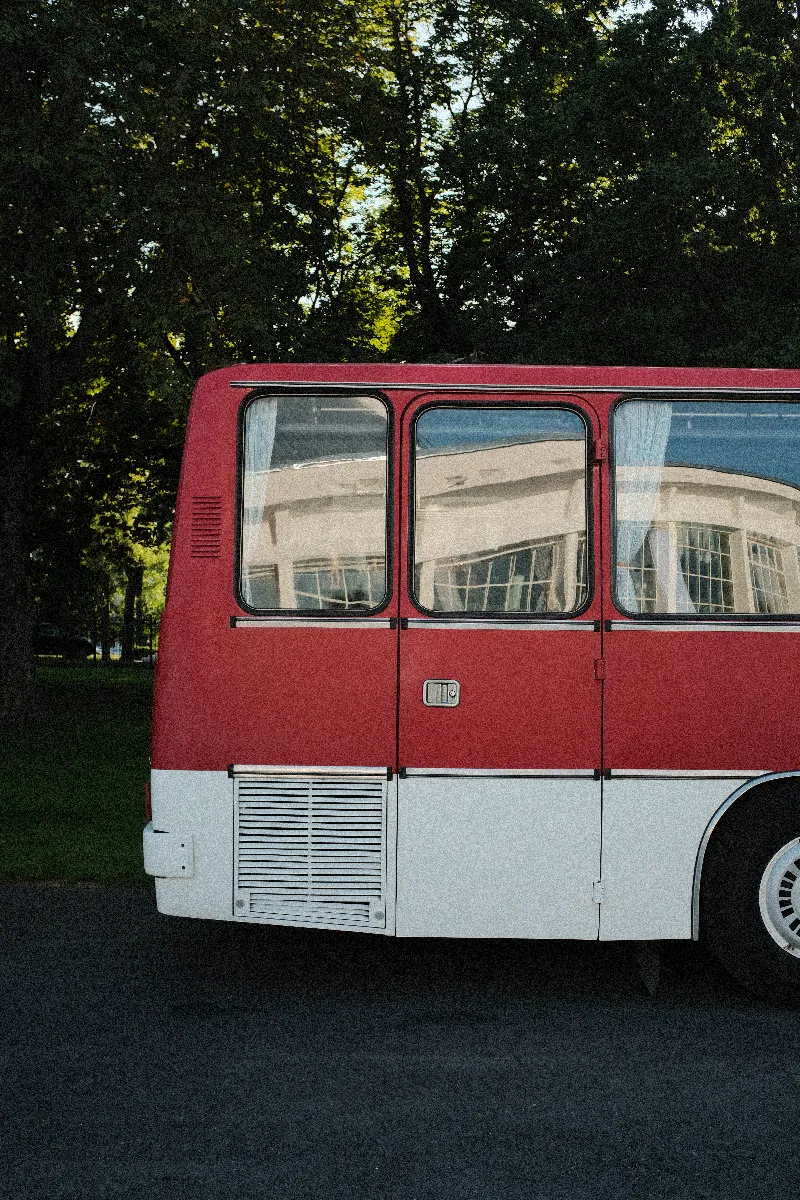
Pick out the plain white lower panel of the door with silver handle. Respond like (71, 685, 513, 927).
(397, 775, 601, 938)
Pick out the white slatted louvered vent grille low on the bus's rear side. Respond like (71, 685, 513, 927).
(235, 776, 386, 928)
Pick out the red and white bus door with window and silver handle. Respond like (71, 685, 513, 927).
(397, 395, 602, 938)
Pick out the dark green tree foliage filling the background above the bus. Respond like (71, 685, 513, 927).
(0, 0, 800, 715)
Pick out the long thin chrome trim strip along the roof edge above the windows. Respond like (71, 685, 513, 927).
(229, 379, 800, 400)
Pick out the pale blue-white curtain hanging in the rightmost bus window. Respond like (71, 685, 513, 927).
(614, 400, 672, 612)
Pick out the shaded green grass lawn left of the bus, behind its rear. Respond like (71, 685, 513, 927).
(0, 665, 154, 883)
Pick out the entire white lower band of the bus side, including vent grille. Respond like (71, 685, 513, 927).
(149, 770, 758, 940)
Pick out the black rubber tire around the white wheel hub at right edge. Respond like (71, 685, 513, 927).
(700, 779, 800, 1007)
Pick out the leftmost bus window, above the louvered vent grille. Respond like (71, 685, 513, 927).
(240, 396, 389, 613)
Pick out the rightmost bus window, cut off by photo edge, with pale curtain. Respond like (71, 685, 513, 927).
(614, 400, 800, 618)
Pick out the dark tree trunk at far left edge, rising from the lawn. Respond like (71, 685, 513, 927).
(0, 439, 36, 728)
